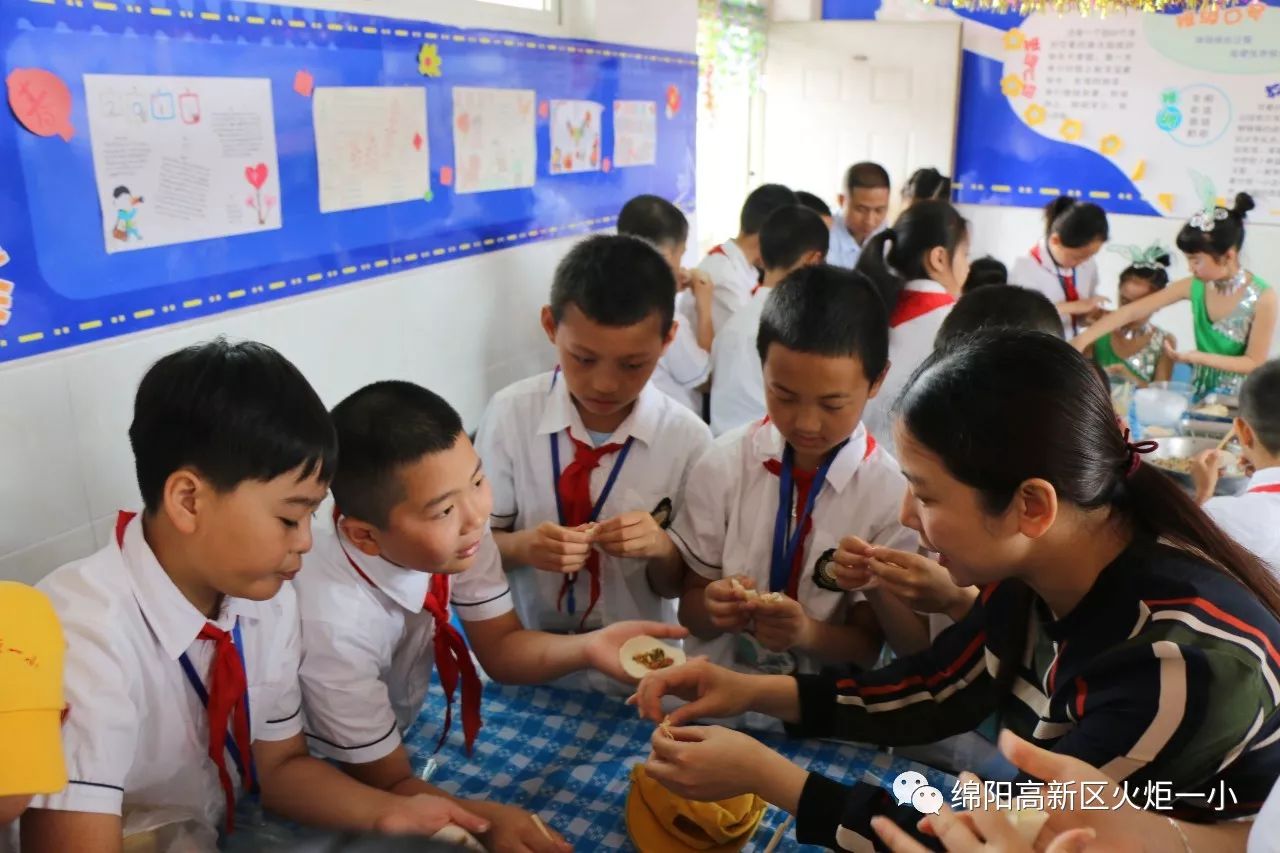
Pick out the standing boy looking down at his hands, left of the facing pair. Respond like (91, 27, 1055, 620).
(476, 236, 710, 692)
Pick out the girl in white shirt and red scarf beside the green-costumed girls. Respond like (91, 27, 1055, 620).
(1009, 196, 1110, 338)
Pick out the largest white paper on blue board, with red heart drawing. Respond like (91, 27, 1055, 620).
(84, 74, 282, 254)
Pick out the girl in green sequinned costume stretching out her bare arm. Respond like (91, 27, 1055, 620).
(1071, 188, 1276, 396)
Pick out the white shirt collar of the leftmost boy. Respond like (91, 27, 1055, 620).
(119, 514, 256, 661)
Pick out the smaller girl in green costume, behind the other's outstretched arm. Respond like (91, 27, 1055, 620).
(1092, 243, 1178, 387)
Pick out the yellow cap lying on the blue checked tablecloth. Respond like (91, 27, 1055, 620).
(627, 765, 768, 853)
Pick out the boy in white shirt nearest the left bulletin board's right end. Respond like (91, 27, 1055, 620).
(618, 195, 716, 416)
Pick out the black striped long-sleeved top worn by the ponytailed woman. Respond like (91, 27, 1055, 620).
(794, 542, 1280, 849)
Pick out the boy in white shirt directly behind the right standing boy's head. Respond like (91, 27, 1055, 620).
(712, 205, 831, 435)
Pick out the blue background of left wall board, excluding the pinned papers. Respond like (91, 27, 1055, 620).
(0, 0, 698, 362)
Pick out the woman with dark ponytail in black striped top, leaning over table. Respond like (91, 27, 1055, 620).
(635, 329, 1280, 850)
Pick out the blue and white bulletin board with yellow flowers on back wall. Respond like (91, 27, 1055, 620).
(823, 0, 1280, 223)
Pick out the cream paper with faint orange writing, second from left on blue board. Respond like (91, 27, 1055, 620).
(311, 86, 431, 213)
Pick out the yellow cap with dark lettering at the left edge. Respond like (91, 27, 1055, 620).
(0, 580, 67, 797)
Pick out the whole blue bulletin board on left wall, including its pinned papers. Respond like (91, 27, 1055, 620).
(0, 0, 696, 362)
